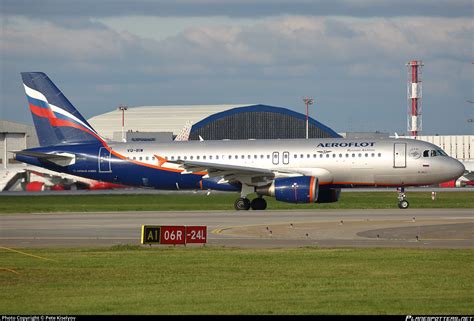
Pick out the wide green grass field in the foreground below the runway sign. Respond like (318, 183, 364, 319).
(0, 245, 474, 315)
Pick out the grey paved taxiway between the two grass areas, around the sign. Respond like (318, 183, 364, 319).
(0, 209, 474, 248)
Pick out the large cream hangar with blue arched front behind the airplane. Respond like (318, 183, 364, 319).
(88, 105, 340, 140)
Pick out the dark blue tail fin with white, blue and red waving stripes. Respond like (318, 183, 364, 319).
(21, 72, 104, 146)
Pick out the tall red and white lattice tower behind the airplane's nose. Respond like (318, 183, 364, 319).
(407, 60, 423, 137)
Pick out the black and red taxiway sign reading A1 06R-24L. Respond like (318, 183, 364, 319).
(141, 225, 207, 245)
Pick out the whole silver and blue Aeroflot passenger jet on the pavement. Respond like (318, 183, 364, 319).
(15, 72, 464, 210)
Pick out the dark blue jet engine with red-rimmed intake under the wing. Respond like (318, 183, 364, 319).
(255, 176, 319, 203)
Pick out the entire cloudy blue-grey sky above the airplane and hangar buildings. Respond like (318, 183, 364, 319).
(0, 0, 474, 135)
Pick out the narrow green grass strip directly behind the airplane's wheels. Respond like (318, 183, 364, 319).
(0, 191, 474, 213)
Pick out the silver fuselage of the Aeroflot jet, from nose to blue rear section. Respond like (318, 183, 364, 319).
(110, 138, 464, 186)
